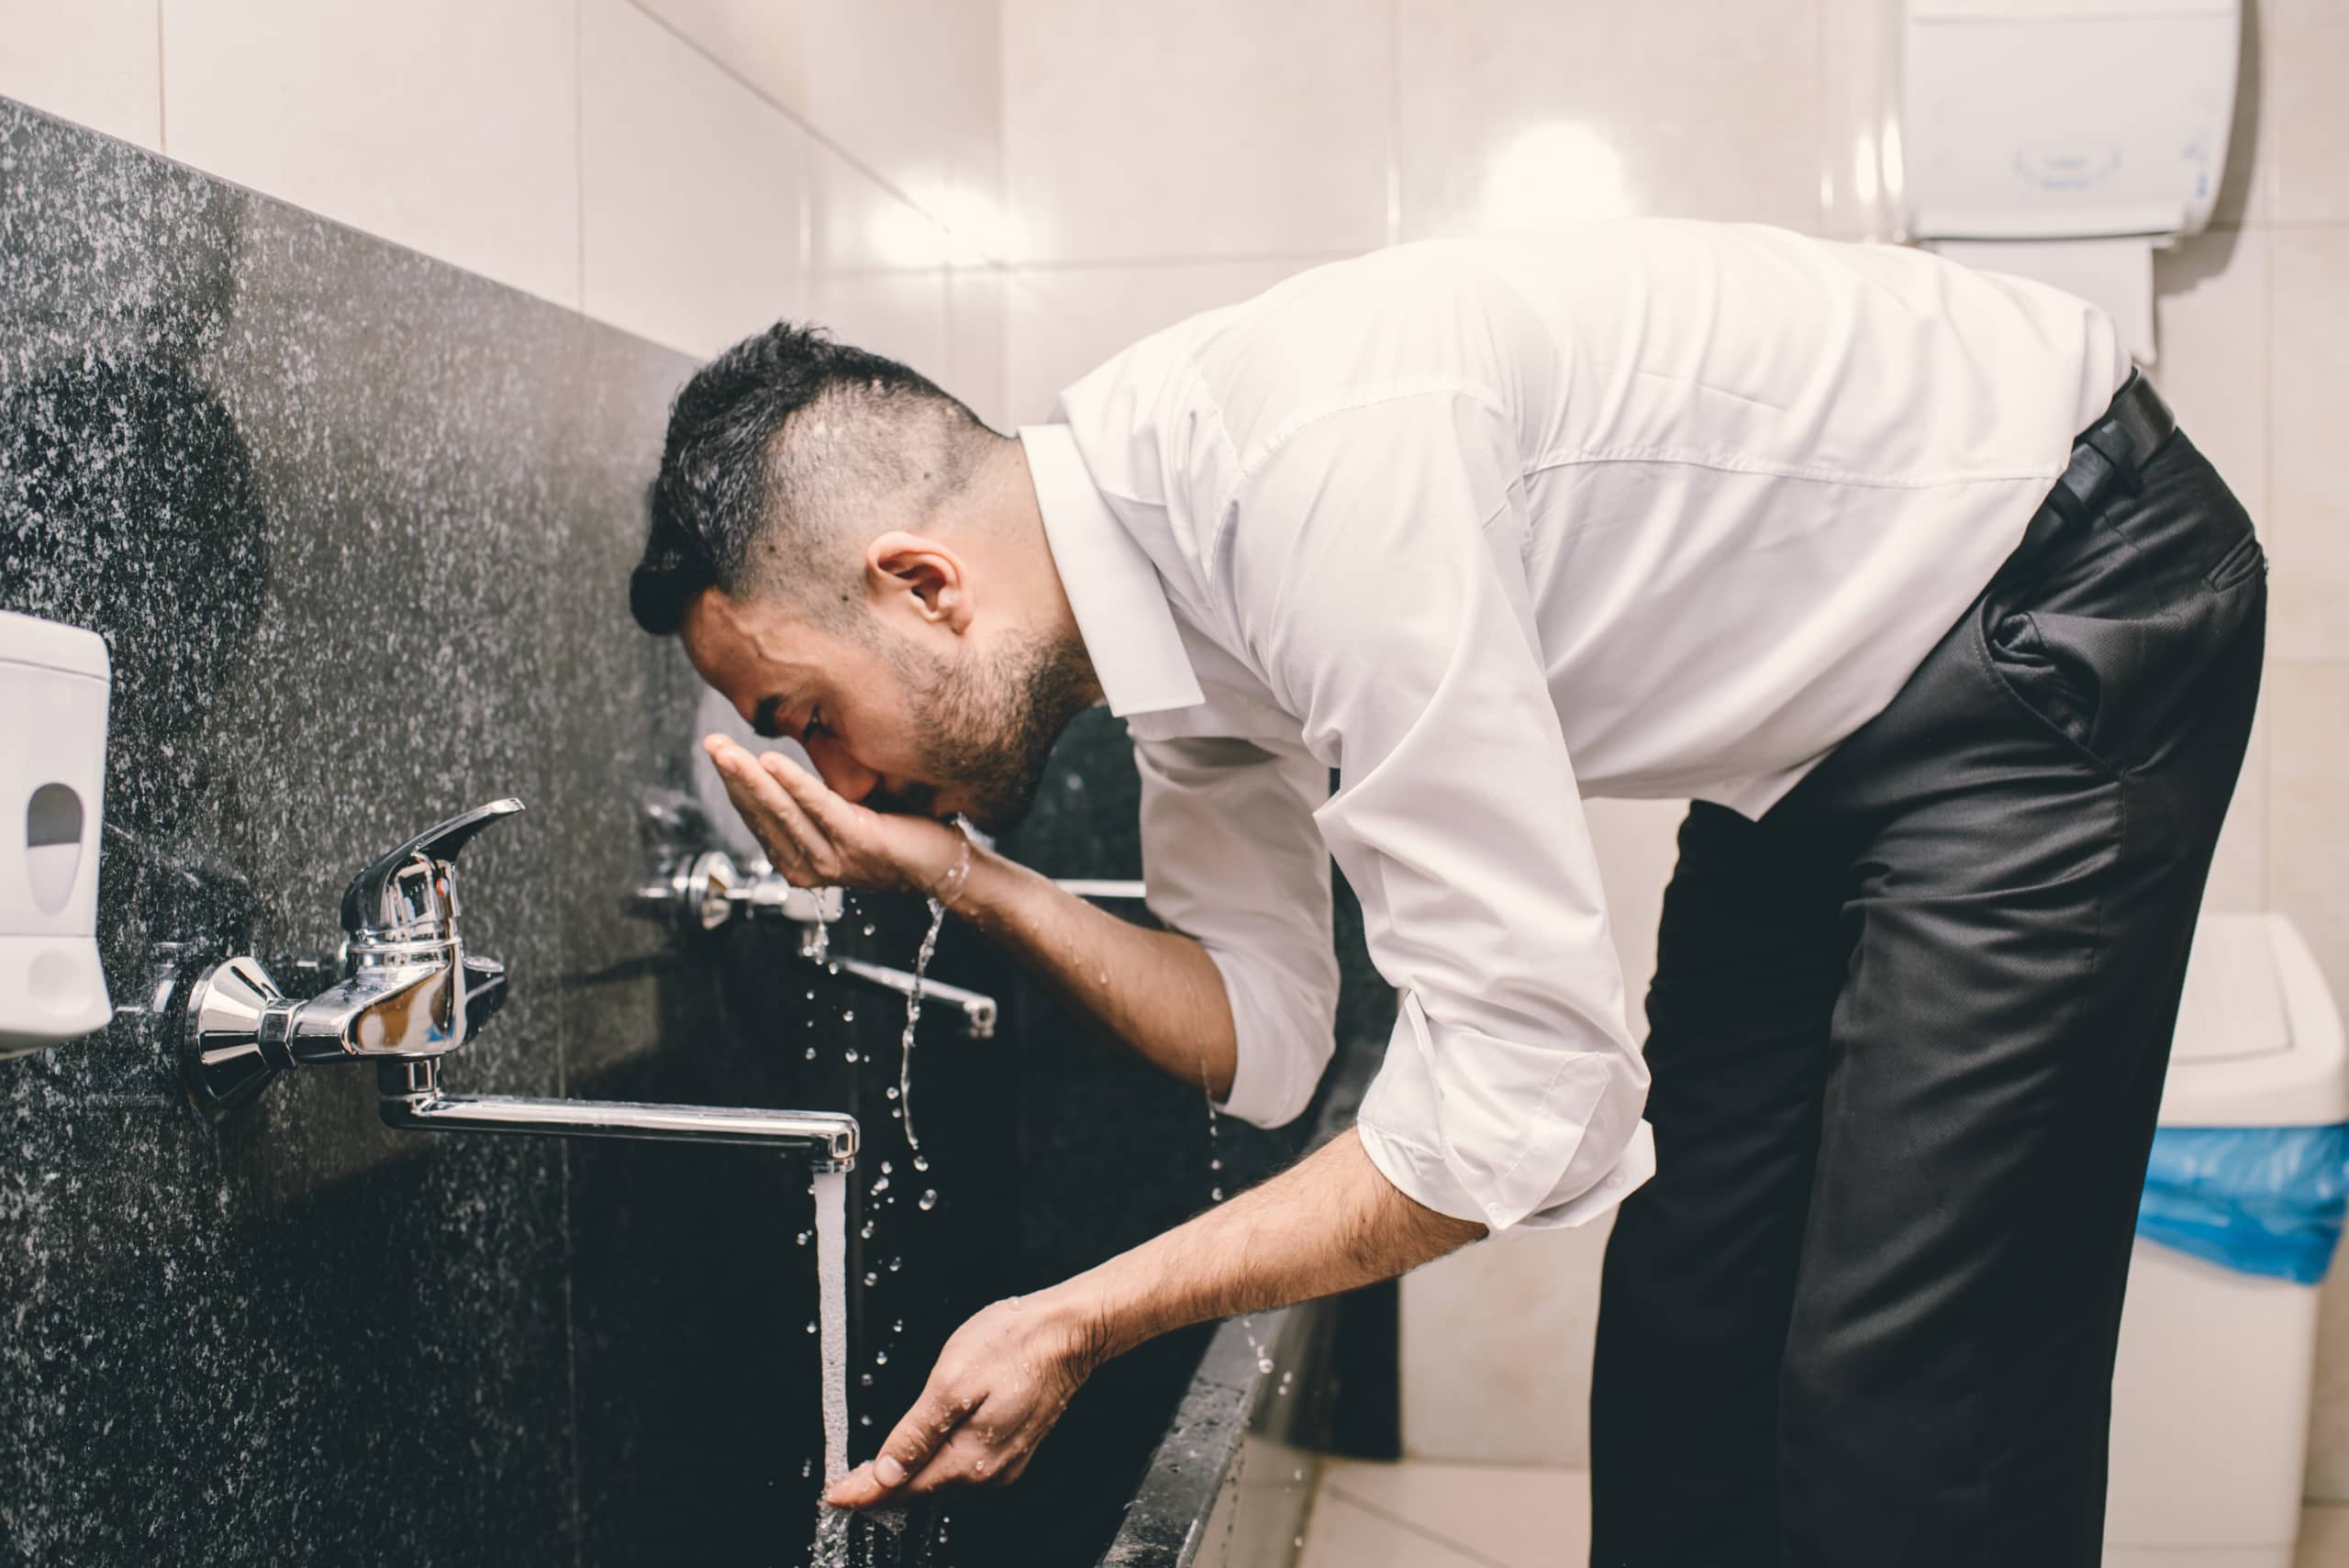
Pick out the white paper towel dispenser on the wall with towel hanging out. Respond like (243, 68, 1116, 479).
(1887, 0, 2243, 361)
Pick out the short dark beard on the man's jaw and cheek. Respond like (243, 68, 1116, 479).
(864, 636, 1095, 833)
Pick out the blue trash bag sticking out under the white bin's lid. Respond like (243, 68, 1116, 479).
(2138, 1124, 2349, 1284)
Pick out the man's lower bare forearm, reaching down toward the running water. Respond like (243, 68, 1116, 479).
(1052, 1129, 1485, 1362)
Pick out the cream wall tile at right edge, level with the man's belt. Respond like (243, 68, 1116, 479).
(2266, 226, 2349, 660)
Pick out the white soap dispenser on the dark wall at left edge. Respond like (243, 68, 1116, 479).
(0, 610, 115, 1056)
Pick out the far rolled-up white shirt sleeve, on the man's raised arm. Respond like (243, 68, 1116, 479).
(1134, 735, 1337, 1127)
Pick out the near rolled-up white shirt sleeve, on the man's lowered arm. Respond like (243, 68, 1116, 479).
(1221, 392, 1653, 1230)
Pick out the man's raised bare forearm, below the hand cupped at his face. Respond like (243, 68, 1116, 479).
(953, 848, 1238, 1098)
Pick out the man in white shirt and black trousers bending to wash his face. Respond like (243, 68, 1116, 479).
(632, 220, 2265, 1568)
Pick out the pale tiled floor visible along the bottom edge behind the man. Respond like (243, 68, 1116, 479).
(1299, 1460, 2349, 1568)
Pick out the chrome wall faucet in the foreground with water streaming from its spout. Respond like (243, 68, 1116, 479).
(184, 800, 857, 1169)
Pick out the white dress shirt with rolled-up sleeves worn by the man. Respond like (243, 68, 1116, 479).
(1019, 220, 2128, 1230)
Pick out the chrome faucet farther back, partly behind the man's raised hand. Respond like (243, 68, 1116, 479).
(628, 789, 998, 1040)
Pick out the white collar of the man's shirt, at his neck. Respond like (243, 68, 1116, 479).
(1019, 425, 1208, 718)
